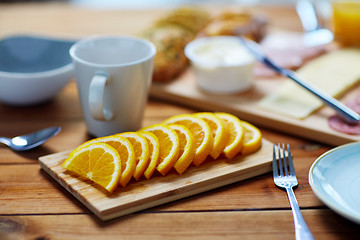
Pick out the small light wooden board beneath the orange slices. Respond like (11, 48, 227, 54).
(39, 139, 272, 220)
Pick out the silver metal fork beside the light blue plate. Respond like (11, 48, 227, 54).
(273, 144, 314, 240)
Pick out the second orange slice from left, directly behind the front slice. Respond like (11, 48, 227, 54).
(74, 135, 136, 187)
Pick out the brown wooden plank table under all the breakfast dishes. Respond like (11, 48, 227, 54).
(0, 3, 360, 240)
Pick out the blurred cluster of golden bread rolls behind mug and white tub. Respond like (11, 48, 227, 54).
(140, 7, 266, 82)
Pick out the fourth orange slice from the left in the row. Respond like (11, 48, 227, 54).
(139, 131, 160, 179)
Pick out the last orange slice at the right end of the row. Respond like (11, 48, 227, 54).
(241, 121, 262, 154)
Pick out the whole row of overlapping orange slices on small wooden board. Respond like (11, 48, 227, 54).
(63, 112, 262, 192)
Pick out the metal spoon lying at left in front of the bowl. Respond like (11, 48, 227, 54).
(0, 127, 61, 151)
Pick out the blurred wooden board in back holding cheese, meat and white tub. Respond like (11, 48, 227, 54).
(150, 68, 360, 146)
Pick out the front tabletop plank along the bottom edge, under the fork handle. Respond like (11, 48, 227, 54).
(0, 209, 360, 240)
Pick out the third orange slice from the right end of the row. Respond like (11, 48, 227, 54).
(194, 112, 229, 159)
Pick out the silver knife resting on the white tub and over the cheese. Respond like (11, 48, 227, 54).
(239, 37, 360, 124)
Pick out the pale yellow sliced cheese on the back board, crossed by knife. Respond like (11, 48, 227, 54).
(258, 48, 360, 119)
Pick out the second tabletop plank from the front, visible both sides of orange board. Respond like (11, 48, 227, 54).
(0, 154, 324, 214)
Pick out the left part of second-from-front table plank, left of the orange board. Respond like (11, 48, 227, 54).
(0, 164, 87, 215)
